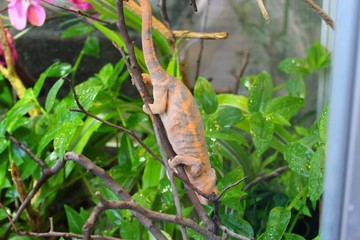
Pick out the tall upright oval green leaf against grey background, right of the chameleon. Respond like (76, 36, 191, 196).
(248, 72, 273, 112)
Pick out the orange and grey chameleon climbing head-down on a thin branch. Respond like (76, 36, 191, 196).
(140, 0, 217, 204)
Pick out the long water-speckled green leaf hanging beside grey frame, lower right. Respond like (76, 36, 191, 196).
(309, 145, 326, 201)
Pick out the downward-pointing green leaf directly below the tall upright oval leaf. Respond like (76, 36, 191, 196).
(250, 113, 274, 155)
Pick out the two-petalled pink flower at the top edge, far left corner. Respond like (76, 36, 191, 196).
(8, 0, 50, 30)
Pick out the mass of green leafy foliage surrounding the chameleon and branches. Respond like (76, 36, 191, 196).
(0, 0, 330, 239)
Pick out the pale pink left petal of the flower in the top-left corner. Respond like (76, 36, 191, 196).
(8, 0, 29, 30)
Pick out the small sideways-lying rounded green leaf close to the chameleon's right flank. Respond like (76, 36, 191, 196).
(214, 106, 244, 127)
